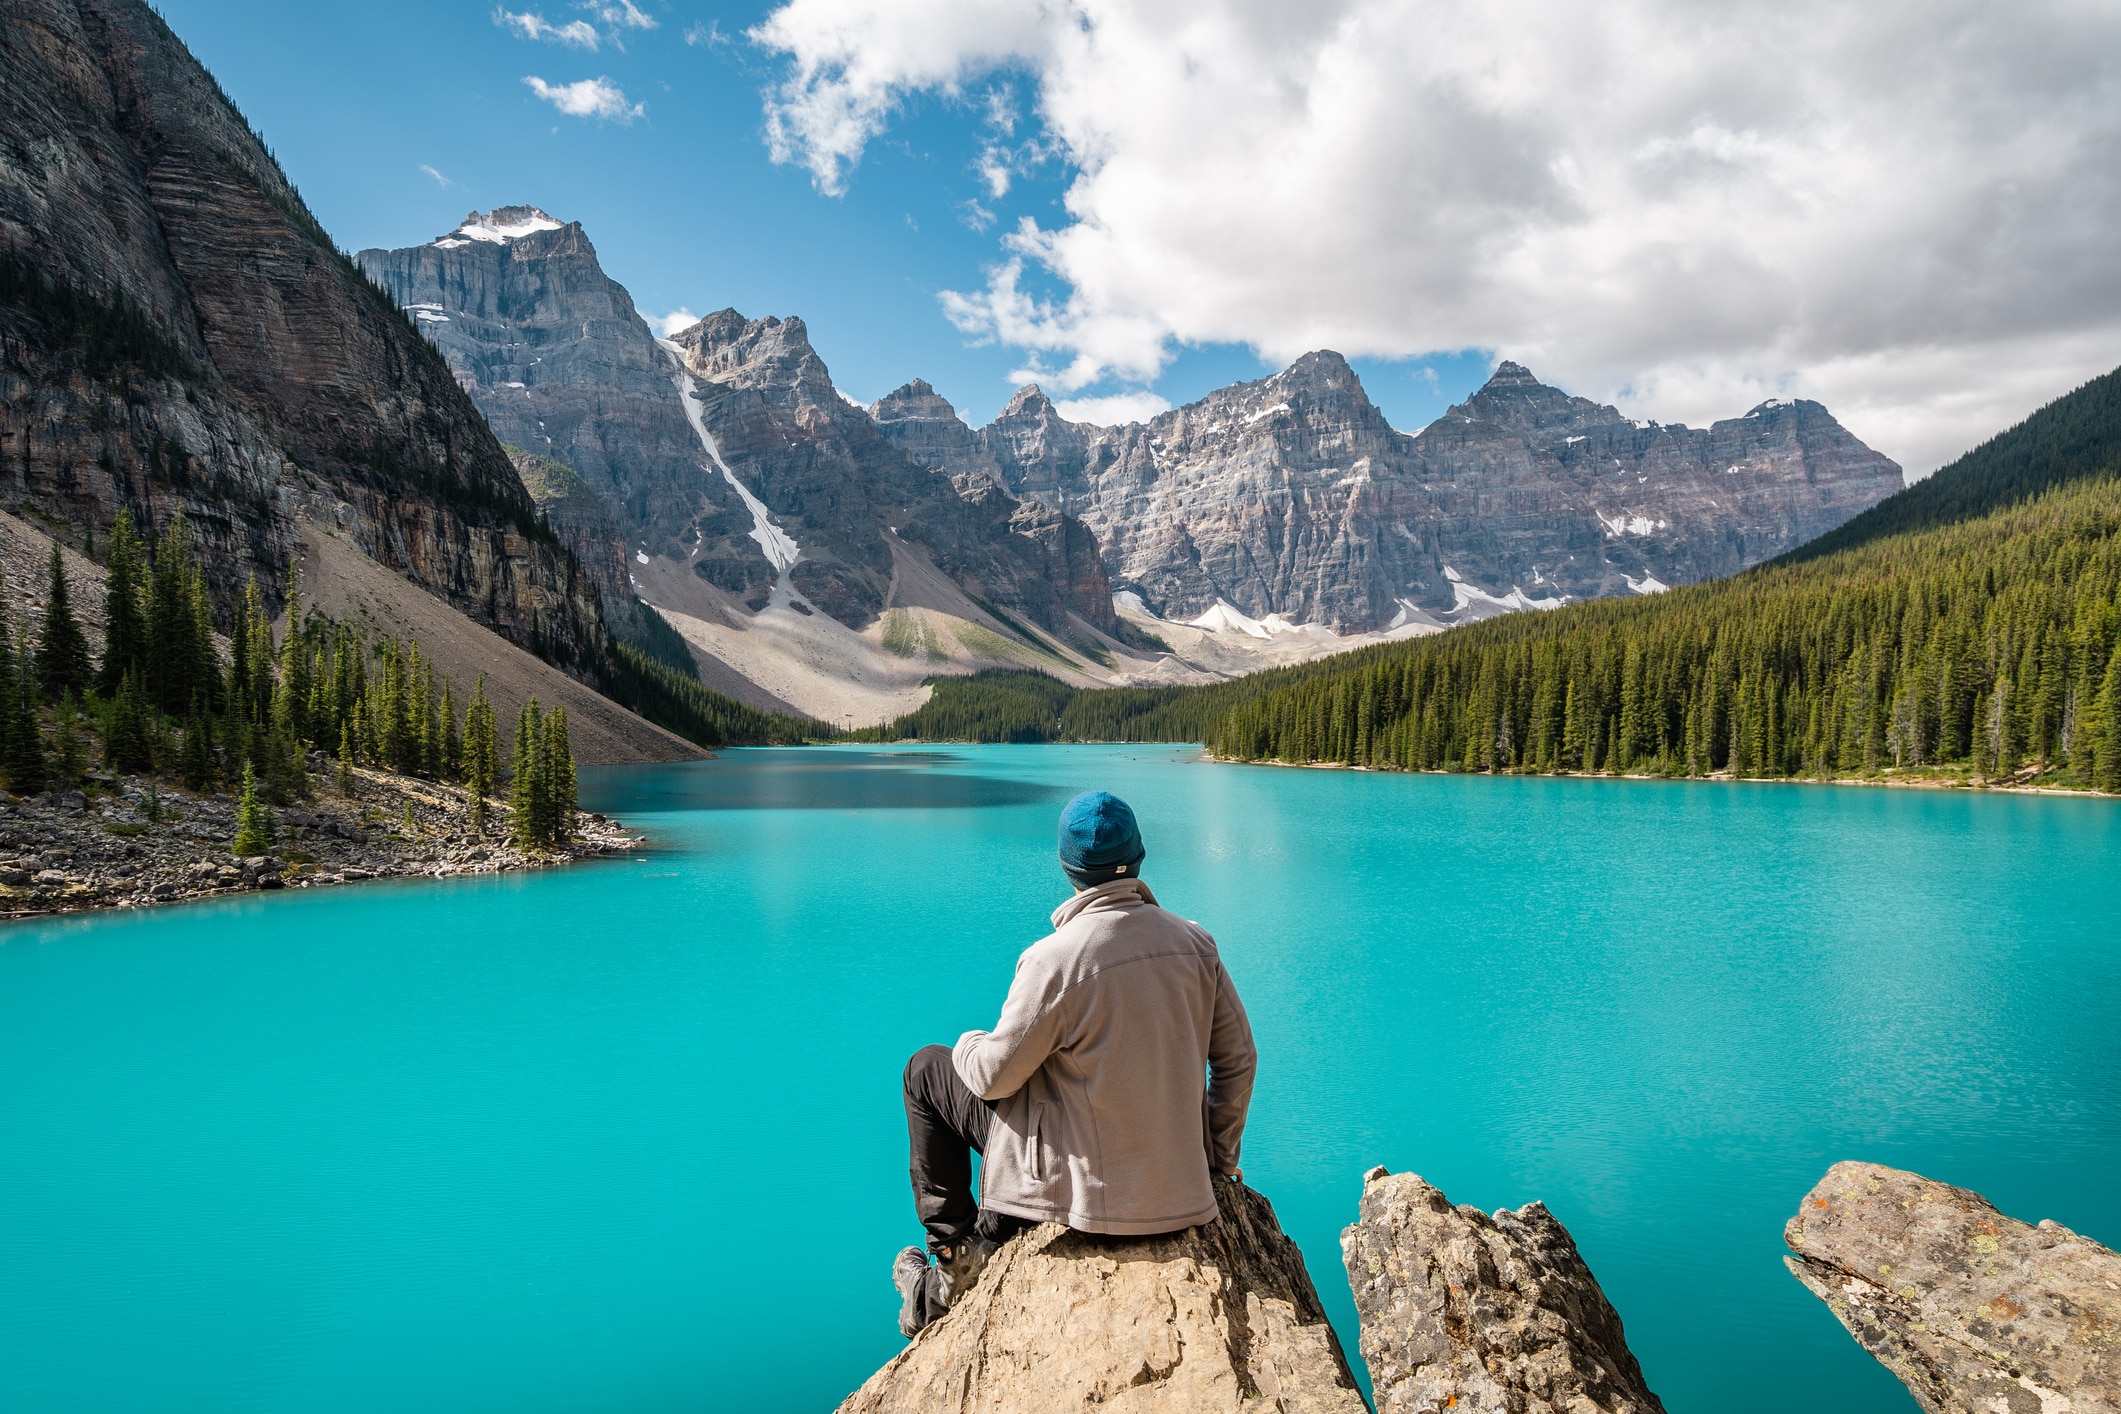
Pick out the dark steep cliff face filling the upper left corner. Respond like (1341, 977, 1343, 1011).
(0, 0, 602, 664)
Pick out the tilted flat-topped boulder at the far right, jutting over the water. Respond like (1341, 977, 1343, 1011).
(1782, 1162, 2121, 1414)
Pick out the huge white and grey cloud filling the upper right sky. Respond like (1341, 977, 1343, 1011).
(751, 0, 2121, 473)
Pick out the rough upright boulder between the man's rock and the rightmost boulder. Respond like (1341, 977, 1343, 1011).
(1340, 1168, 1665, 1414)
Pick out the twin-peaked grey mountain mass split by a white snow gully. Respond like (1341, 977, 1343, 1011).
(358, 216, 1118, 632)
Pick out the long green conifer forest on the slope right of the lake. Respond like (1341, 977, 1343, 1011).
(876, 477, 2121, 791)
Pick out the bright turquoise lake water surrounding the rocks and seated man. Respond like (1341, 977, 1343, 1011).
(0, 746, 2121, 1414)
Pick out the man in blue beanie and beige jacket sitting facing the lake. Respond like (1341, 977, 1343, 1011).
(891, 791, 1256, 1338)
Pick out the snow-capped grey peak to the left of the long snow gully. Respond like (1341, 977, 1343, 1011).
(354, 206, 749, 555)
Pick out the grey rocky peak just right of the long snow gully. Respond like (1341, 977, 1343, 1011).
(668, 310, 1116, 632)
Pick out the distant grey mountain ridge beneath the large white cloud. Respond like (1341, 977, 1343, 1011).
(872, 350, 1900, 632)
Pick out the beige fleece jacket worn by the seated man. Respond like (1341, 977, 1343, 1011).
(950, 880, 1256, 1234)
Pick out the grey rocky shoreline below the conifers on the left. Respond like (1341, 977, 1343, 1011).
(0, 753, 641, 918)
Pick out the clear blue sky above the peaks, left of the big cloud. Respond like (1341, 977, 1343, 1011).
(161, 0, 1493, 428)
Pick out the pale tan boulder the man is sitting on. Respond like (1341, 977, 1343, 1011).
(840, 1183, 1364, 1414)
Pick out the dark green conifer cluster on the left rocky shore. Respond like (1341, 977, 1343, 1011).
(12, 511, 575, 846)
